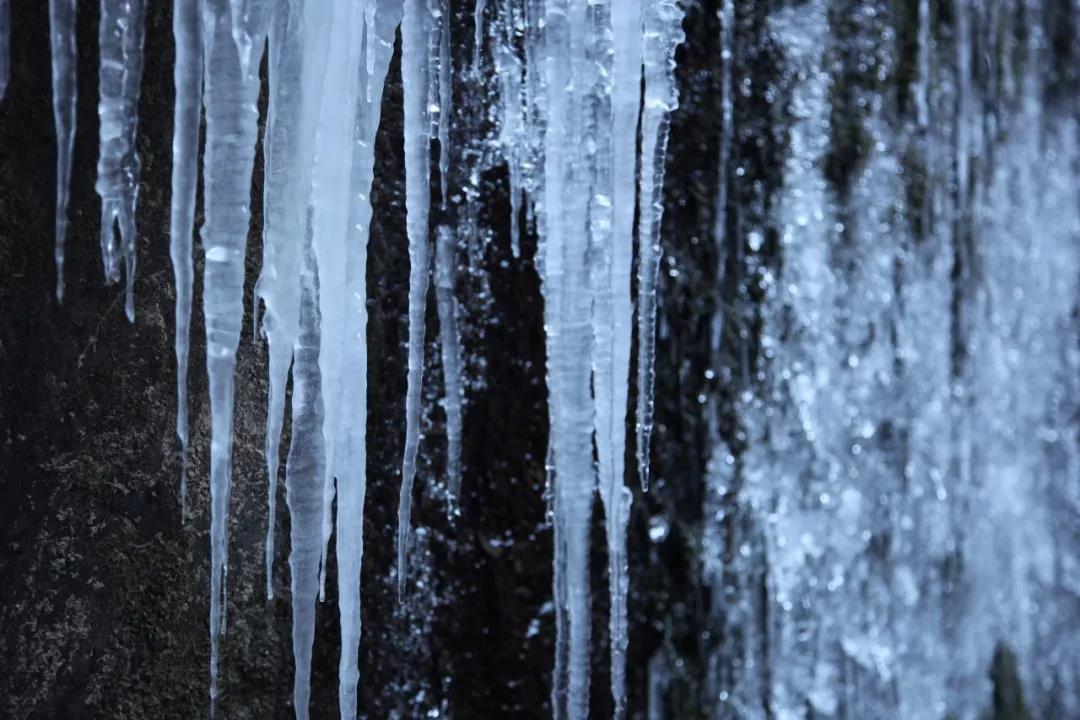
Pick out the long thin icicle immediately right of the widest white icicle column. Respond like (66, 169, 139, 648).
(397, 0, 431, 602)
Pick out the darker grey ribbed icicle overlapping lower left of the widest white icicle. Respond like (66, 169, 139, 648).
(285, 236, 325, 720)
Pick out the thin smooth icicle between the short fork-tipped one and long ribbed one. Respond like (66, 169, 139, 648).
(168, 2, 203, 517)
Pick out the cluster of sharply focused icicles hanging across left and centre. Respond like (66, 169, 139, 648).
(0, 0, 683, 718)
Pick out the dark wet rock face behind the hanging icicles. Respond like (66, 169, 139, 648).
(0, 0, 1080, 720)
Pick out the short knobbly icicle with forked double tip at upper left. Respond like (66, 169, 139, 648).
(95, 0, 146, 321)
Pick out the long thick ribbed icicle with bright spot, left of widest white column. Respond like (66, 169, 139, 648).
(201, 0, 270, 711)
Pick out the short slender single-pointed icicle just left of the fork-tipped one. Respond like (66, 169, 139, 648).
(50, 0, 78, 302)
